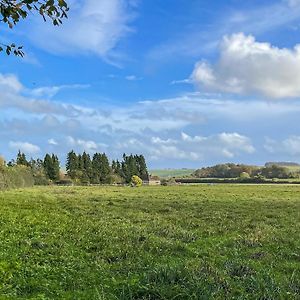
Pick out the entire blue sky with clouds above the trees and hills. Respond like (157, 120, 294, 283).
(0, 0, 300, 168)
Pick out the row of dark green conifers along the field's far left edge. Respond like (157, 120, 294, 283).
(7, 150, 149, 185)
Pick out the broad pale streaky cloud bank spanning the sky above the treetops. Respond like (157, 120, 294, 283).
(0, 72, 300, 167)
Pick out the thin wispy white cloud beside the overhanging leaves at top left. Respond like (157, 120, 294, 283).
(24, 0, 134, 59)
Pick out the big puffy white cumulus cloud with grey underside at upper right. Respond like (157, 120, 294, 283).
(192, 33, 300, 98)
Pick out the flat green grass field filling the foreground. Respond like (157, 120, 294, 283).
(0, 185, 300, 299)
